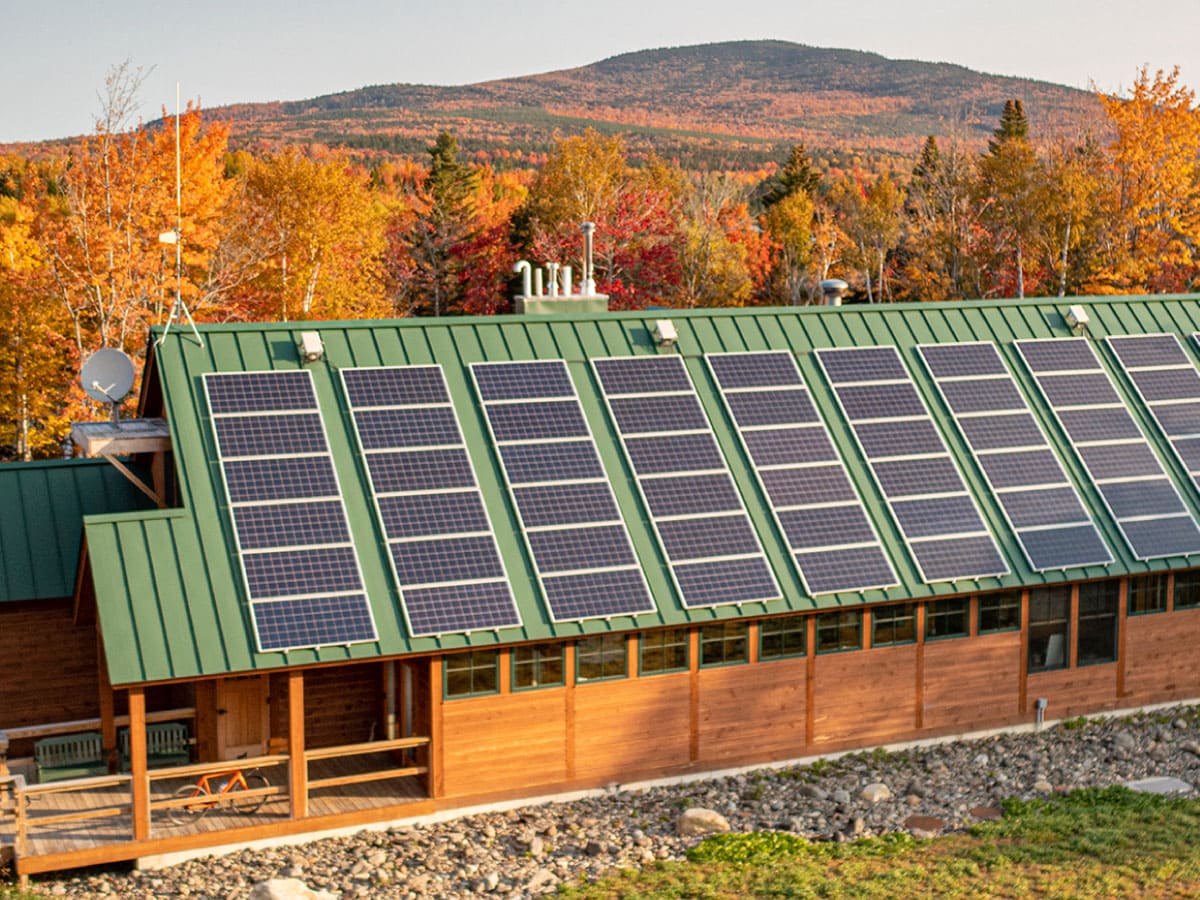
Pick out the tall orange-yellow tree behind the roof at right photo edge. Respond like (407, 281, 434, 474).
(1100, 68, 1200, 290)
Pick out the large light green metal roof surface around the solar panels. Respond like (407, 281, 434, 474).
(86, 295, 1200, 684)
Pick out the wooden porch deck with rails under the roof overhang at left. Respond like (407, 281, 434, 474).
(0, 756, 427, 872)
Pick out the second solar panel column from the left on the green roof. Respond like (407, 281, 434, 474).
(342, 366, 521, 636)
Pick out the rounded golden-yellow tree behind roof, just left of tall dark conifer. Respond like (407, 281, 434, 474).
(240, 149, 388, 322)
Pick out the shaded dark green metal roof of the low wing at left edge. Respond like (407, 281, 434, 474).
(0, 460, 152, 602)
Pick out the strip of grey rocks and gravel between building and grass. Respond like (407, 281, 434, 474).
(14, 707, 1200, 900)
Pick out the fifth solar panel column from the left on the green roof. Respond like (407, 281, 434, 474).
(706, 352, 896, 594)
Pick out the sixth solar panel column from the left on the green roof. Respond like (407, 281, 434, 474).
(816, 347, 1008, 582)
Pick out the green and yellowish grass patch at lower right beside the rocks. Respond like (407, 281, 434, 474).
(563, 787, 1200, 900)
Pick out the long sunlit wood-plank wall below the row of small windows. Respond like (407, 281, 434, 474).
(432, 592, 1200, 799)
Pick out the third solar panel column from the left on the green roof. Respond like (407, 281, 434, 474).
(470, 360, 655, 622)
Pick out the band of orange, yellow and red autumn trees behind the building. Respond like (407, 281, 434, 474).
(0, 67, 1200, 458)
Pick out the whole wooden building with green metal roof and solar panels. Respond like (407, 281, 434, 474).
(7, 295, 1200, 874)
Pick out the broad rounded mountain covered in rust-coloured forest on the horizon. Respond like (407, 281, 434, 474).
(184, 41, 1103, 168)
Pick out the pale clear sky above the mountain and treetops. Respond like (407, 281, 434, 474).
(0, 0, 1200, 143)
